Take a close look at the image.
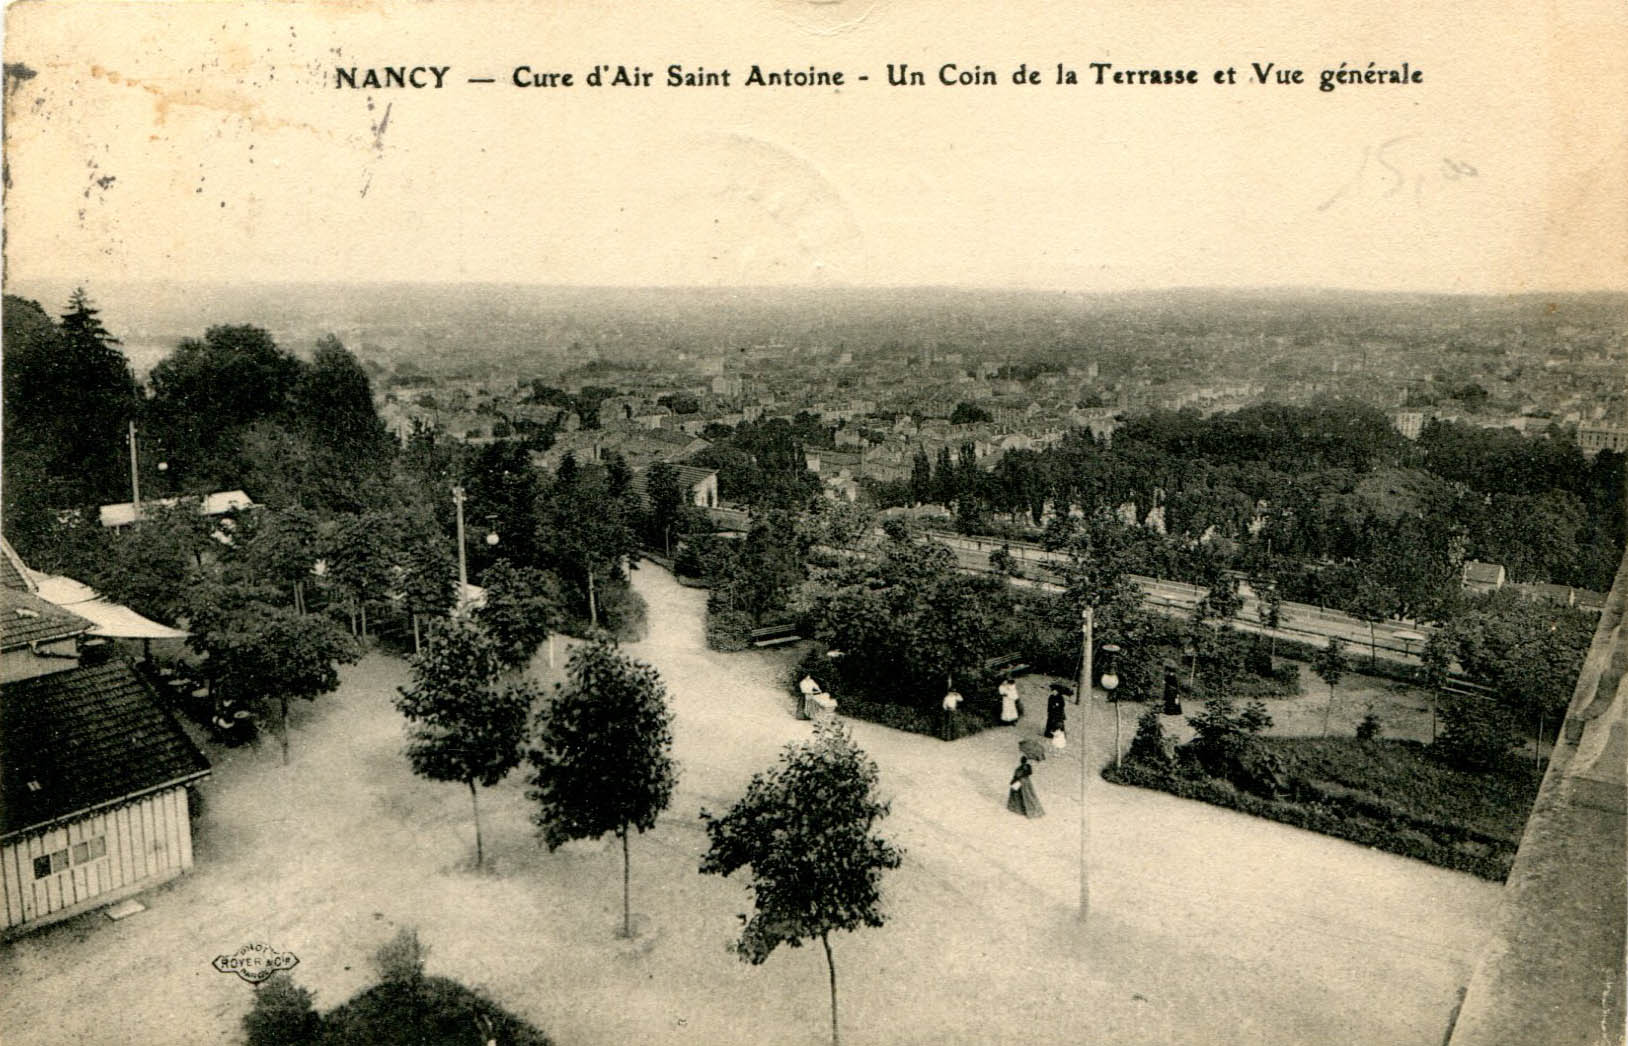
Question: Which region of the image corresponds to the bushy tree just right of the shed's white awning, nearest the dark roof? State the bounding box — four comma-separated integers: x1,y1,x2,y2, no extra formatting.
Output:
186,576,360,763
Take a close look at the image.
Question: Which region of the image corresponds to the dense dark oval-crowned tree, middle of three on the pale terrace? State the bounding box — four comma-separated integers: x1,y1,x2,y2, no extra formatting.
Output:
526,639,677,937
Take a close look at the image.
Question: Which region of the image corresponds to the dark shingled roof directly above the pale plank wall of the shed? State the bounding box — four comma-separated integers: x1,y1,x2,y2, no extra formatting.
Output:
0,660,208,838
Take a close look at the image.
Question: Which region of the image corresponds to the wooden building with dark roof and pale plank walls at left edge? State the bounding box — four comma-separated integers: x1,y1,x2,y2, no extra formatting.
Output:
0,584,208,935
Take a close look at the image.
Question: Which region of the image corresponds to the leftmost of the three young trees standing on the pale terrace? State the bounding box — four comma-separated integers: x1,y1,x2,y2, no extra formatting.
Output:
396,618,537,869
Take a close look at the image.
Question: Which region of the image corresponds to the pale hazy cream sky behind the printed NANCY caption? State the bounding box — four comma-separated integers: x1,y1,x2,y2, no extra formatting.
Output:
5,0,1628,291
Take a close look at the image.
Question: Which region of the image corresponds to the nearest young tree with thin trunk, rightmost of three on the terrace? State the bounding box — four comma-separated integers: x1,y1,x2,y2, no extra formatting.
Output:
702,722,902,1046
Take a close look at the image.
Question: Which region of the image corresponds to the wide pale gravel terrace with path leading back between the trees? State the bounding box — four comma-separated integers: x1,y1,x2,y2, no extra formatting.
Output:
0,563,1499,1046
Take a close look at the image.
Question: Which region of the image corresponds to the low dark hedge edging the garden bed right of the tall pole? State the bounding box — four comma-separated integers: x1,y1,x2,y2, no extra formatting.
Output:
1102,763,1514,883
